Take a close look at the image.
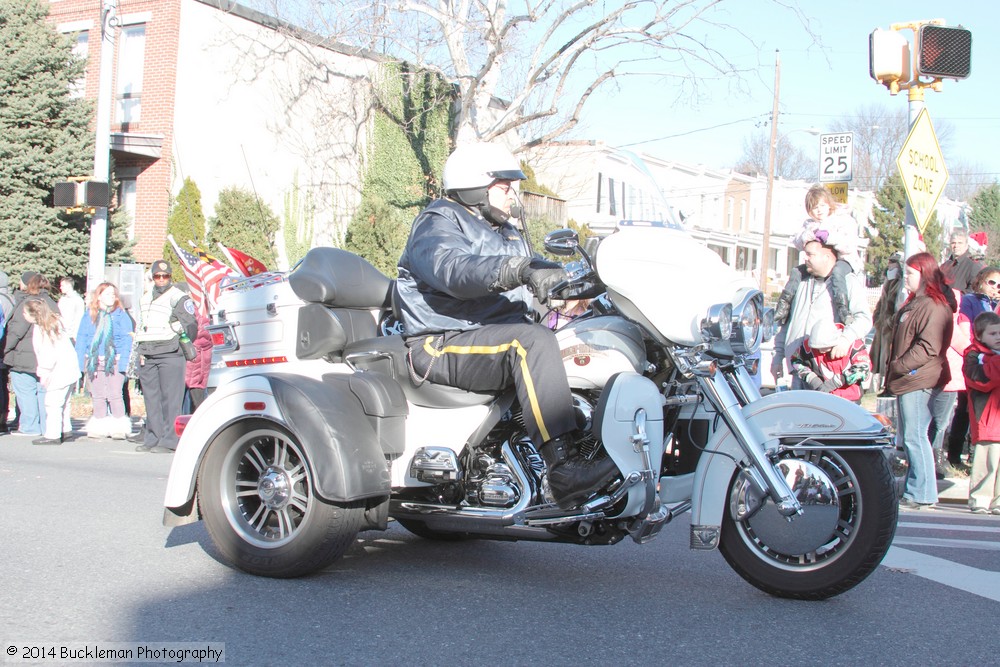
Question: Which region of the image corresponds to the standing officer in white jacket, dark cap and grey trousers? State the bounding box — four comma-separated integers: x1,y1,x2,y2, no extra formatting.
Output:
135,259,198,453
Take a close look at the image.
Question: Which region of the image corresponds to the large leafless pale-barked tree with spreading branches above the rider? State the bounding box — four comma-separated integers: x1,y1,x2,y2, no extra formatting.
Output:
248,0,808,148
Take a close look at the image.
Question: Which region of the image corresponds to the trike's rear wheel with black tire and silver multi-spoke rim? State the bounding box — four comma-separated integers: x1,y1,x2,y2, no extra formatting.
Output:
198,420,364,578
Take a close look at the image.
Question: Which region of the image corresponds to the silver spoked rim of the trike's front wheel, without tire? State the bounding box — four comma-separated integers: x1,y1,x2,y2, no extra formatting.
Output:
736,450,864,572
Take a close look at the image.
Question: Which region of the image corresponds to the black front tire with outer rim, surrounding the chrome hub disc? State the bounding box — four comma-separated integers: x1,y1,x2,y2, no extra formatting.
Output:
719,450,899,600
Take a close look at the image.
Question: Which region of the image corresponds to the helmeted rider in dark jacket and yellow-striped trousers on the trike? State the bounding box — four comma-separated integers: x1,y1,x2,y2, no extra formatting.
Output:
395,144,616,508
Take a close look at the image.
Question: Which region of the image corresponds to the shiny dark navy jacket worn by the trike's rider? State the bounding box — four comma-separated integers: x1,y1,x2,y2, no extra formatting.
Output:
395,199,533,336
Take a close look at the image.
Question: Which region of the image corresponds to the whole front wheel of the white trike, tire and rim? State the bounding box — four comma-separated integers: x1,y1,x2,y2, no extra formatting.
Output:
719,450,898,600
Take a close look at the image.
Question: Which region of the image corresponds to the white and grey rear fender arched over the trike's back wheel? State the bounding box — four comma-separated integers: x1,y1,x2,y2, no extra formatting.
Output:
164,374,394,515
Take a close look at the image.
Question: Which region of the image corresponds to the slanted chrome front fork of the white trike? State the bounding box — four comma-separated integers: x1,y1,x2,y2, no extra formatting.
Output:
698,368,802,517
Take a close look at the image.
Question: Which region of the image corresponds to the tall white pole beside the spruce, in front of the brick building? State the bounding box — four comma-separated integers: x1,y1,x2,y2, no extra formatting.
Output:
87,0,118,292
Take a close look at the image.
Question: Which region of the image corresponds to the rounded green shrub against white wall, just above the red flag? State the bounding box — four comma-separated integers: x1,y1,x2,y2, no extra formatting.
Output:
205,187,281,270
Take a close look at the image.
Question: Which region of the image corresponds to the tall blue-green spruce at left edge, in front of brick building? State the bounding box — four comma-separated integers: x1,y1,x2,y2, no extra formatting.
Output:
0,0,94,279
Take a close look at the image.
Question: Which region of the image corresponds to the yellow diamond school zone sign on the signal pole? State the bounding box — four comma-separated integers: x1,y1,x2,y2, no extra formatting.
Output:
896,109,948,234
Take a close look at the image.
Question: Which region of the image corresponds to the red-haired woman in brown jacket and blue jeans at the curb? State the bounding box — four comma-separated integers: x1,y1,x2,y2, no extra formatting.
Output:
886,252,958,509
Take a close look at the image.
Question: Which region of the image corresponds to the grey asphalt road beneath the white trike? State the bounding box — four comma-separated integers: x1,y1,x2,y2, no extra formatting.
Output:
0,436,1000,667
